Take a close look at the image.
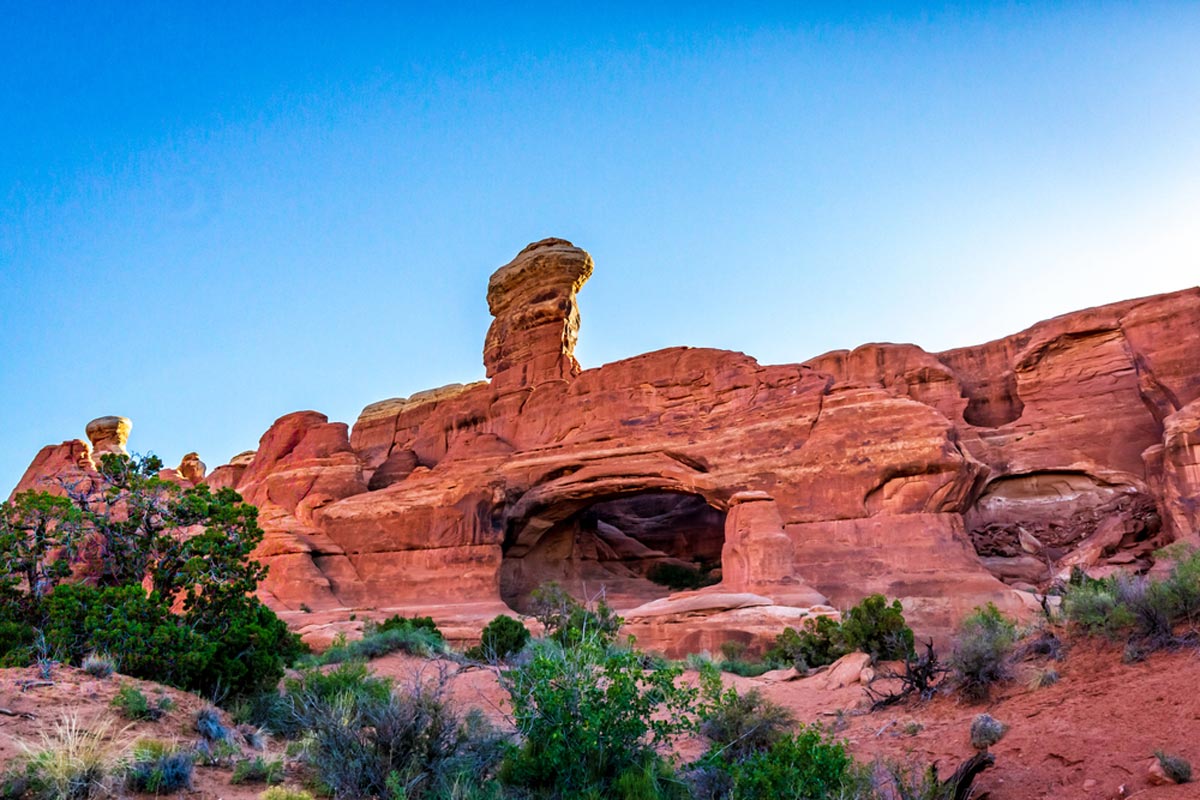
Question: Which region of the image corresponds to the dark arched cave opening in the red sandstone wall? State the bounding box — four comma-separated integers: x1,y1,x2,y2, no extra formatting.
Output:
500,491,725,613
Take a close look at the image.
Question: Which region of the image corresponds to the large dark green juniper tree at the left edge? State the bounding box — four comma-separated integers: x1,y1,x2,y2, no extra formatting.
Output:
0,453,301,696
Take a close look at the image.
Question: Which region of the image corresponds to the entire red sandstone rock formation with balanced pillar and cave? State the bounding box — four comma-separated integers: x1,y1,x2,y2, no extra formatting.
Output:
11,239,1200,652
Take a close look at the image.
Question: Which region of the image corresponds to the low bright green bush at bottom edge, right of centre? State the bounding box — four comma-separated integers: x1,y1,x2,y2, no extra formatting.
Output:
728,726,857,800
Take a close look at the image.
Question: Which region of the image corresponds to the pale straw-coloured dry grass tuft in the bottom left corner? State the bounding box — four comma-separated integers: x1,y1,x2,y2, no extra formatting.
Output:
18,714,128,800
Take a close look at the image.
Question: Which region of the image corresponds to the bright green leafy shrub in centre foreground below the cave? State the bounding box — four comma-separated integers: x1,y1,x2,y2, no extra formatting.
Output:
500,628,696,796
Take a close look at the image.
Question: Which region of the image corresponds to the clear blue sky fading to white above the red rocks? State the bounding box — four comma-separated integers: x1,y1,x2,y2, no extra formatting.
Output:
0,0,1200,495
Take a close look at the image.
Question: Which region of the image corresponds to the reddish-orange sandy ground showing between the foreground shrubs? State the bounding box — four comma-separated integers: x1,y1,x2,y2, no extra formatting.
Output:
0,642,1200,800
